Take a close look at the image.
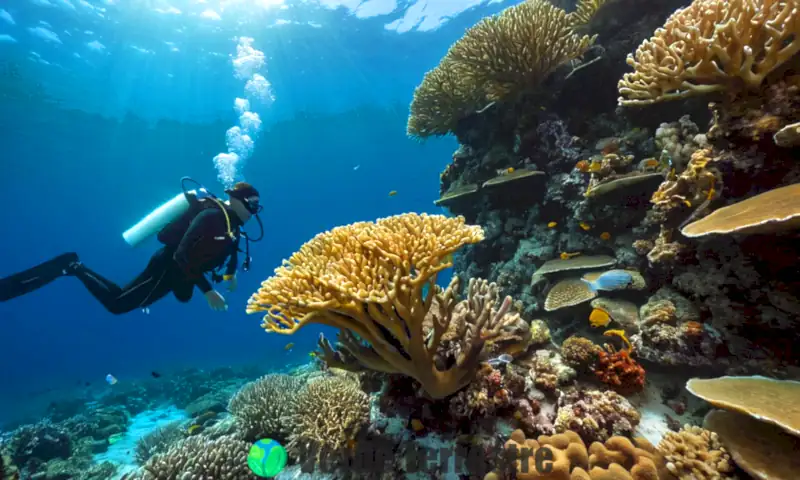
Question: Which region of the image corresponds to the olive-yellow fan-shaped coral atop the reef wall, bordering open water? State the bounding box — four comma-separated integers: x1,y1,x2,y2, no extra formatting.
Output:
407,0,595,137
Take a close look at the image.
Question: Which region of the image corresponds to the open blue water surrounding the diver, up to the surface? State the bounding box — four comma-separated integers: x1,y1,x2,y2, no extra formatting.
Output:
0,0,514,423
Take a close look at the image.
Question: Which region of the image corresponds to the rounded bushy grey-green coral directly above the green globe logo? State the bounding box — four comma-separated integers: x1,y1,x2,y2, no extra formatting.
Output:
228,374,302,440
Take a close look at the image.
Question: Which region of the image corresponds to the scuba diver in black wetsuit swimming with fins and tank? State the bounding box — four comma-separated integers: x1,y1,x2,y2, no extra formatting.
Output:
0,177,264,315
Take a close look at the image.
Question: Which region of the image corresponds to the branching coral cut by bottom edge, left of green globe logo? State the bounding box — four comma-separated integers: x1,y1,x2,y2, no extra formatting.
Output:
127,436,258,480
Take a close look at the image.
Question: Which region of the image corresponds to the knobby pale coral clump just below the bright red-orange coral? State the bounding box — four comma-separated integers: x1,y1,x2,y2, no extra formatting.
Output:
555,390,641,442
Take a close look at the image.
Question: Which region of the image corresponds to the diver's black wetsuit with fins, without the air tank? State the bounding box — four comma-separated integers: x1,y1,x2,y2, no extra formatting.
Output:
0,204,242,314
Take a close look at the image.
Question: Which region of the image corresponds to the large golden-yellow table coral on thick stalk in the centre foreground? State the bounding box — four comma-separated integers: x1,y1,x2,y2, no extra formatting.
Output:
247,213,511,398
